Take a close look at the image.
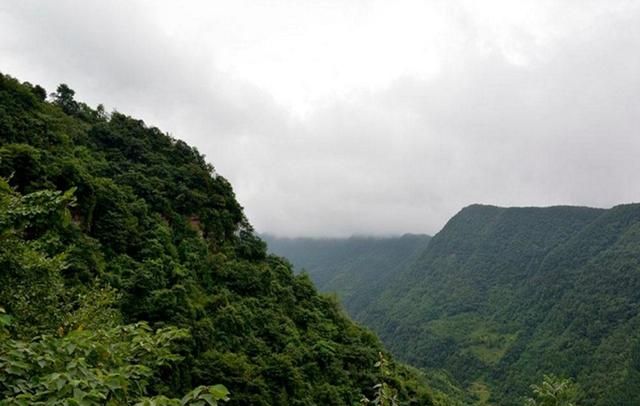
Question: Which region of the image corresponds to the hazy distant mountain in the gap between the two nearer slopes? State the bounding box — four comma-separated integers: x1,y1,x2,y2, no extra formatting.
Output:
262,234,431,320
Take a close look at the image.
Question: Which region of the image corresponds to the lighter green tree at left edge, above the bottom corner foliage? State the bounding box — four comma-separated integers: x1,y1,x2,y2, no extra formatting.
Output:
0,179,73,336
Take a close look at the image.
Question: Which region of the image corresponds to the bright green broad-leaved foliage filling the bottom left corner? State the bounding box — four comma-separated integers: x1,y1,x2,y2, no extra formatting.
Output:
0,323,188,405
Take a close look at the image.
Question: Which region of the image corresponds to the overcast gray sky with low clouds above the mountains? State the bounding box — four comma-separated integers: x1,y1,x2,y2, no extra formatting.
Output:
0,0,640,236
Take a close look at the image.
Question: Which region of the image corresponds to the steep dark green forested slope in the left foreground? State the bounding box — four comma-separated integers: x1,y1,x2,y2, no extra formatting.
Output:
0,75,450,405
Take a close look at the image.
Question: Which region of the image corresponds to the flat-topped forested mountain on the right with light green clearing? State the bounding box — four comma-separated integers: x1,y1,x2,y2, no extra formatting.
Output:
290,205,640,406
